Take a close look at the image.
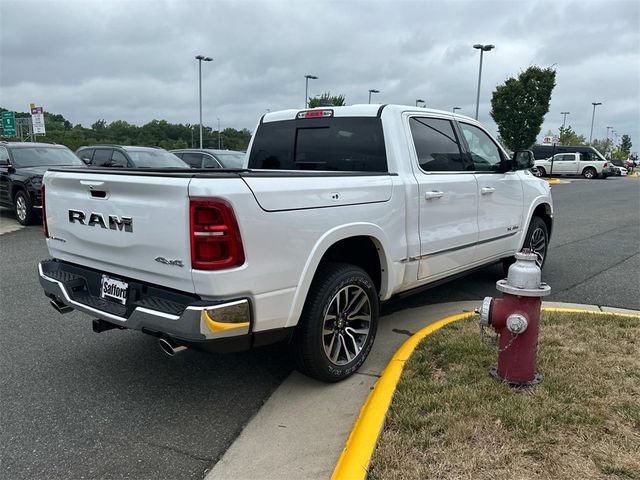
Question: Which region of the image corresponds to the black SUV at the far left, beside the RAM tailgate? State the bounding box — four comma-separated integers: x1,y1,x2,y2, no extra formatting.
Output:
0,142,86,225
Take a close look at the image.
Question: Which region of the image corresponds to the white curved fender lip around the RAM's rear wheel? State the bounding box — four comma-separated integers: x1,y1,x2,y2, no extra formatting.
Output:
286,223,395,327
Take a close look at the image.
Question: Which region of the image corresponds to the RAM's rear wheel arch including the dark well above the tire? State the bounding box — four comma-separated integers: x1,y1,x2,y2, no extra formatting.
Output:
286,223,392,327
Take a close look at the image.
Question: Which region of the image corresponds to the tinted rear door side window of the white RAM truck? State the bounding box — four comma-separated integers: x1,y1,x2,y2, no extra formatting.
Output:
409,117,465,172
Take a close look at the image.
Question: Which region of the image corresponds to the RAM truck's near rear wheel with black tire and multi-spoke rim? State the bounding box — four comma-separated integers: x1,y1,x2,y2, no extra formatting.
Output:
293,263,379,382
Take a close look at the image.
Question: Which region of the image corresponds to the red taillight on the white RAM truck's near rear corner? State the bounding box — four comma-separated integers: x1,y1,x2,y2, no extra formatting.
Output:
189,199,244,270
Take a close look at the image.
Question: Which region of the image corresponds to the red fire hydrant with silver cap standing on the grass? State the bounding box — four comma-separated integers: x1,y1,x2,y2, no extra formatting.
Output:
476,250,551,387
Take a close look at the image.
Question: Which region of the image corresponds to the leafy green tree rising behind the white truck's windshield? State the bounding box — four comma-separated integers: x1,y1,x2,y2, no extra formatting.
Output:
490,66,556,150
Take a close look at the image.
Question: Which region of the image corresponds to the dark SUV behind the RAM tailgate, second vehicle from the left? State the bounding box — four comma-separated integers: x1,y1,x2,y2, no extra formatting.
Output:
76,145,189,168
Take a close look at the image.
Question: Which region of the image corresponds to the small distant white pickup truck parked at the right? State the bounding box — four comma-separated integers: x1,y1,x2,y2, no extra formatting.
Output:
534,152,613,179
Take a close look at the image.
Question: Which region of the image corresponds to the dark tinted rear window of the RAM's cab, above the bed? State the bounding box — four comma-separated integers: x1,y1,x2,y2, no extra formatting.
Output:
249,117,387,172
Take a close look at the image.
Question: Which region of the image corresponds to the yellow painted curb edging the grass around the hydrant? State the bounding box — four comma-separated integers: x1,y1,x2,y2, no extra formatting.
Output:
331,308,640,480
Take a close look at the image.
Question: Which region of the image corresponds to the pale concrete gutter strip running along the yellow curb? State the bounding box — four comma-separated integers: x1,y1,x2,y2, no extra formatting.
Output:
206,299,639,480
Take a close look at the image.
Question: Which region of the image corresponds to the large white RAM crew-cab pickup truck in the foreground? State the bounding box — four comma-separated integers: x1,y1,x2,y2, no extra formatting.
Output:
39,105,553,381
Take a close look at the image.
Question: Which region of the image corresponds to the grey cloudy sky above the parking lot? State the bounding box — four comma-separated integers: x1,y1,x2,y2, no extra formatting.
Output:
0,0,640,146
